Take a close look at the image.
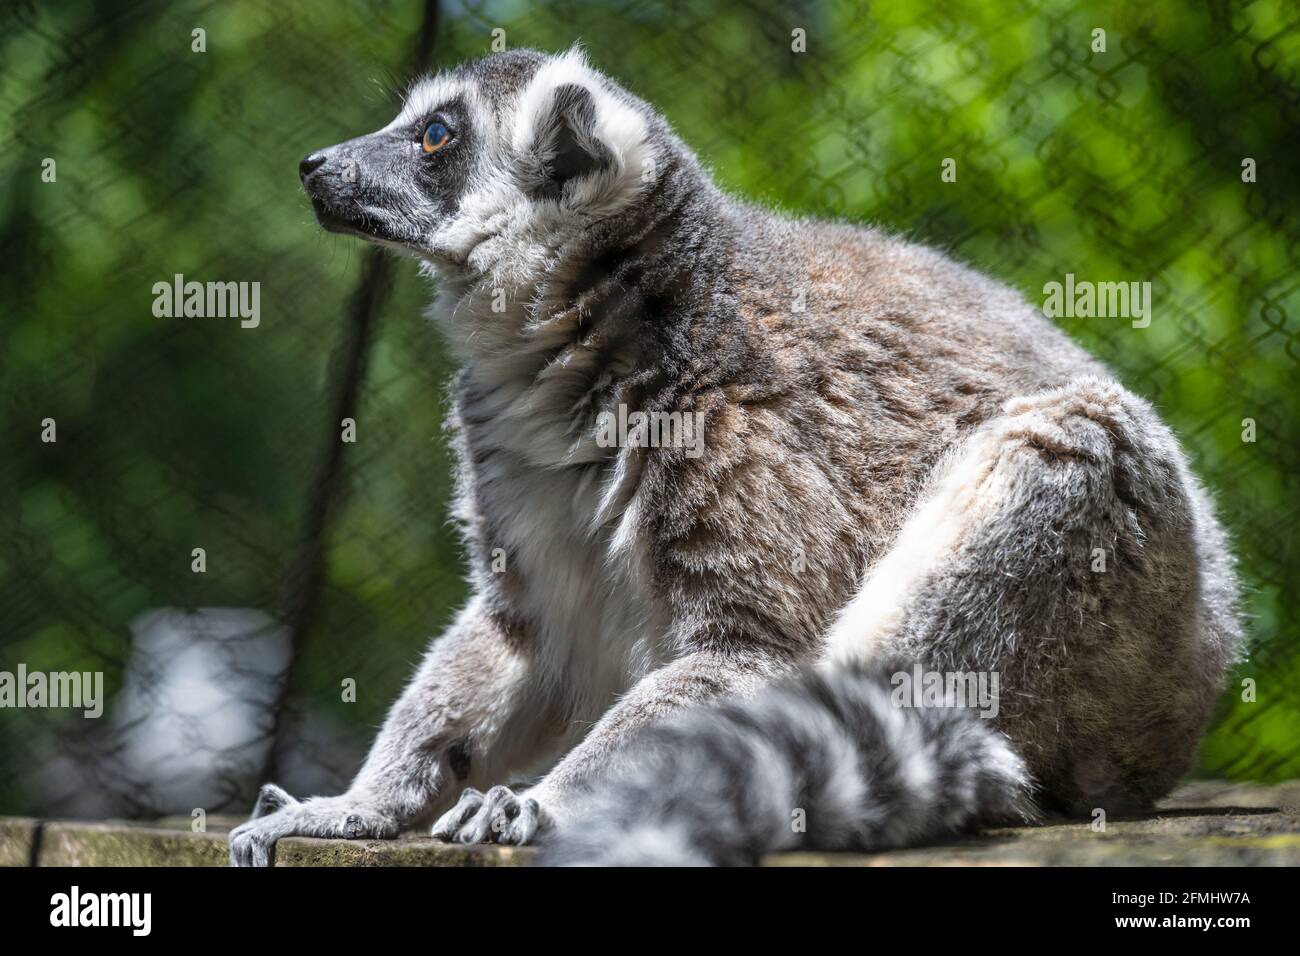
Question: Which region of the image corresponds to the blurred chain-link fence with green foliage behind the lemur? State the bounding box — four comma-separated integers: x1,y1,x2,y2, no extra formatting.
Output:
0,0,1300,816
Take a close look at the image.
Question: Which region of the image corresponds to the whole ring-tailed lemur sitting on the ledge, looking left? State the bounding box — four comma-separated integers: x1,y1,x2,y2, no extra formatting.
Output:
230,51,1240,865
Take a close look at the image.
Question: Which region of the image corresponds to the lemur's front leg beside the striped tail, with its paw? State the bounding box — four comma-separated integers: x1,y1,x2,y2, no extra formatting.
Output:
433,650,793,845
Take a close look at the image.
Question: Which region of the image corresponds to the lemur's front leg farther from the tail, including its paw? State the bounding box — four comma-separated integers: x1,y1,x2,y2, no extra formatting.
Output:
230,600,556,866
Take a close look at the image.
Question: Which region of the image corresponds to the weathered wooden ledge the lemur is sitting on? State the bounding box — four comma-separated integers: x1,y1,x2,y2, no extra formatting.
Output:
0,780,1300,866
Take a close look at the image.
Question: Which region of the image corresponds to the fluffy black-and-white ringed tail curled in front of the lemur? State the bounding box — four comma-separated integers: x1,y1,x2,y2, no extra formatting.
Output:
542,667,1034,866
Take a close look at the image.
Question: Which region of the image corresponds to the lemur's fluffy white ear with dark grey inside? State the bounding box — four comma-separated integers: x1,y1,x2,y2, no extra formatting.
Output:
514,49,650,212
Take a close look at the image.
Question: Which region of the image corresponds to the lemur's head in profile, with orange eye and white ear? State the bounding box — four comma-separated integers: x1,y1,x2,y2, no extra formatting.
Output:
299,51,658,273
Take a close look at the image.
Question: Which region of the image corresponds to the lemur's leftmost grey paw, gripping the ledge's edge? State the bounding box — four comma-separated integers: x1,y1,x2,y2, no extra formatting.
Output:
230,783,398,866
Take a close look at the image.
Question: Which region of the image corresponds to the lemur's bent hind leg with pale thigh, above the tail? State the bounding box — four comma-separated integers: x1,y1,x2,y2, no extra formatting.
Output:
828,378,1223,813
